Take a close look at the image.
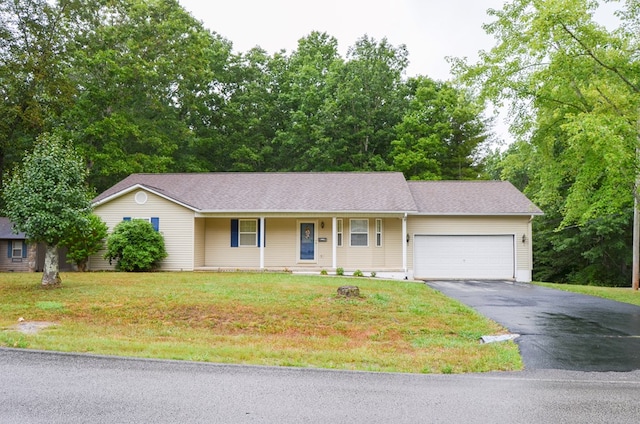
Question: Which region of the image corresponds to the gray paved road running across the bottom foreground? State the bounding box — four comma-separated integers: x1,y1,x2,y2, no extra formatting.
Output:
0,348,640,424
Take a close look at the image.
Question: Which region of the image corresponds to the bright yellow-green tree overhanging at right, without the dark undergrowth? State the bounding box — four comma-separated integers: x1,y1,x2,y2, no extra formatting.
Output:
455,0,640,287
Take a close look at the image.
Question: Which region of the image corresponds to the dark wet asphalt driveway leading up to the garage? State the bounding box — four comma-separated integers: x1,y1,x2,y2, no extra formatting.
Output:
427,281,640,371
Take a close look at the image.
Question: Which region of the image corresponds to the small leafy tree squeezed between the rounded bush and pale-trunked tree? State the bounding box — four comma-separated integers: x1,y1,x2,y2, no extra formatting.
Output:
60,213,108,271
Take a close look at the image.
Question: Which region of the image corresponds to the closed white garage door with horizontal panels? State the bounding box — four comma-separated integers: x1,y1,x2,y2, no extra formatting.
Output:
414,235,515,279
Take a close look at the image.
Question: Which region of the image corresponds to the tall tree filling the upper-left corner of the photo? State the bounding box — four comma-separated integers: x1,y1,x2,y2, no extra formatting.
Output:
0,0,90,199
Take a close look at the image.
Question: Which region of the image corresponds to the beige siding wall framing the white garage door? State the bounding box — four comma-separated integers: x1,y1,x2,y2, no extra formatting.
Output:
407,216,532,272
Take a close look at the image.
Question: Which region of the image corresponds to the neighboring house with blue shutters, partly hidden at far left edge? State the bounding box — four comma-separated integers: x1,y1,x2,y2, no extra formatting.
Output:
0,217,74,272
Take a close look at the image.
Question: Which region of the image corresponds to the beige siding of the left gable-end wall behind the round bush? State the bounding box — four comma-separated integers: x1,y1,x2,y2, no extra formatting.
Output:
89,190,194,271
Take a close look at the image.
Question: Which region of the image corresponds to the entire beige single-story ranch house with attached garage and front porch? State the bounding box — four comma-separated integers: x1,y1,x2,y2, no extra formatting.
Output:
89,172,542,281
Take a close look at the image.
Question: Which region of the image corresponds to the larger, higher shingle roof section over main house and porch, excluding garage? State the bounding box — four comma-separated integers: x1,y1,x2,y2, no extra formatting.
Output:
94,172,416,212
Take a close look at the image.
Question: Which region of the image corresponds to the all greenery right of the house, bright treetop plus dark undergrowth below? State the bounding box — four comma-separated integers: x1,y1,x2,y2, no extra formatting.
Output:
455,0,640,285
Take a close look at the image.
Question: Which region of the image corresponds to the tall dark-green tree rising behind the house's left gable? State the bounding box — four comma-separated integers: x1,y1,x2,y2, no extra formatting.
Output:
63,0,231,190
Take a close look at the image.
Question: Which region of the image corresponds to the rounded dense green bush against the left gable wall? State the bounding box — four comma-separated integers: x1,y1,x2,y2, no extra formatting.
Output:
104,219,167,272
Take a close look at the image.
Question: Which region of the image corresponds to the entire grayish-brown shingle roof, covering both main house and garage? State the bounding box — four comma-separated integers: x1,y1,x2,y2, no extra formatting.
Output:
93,172,542,215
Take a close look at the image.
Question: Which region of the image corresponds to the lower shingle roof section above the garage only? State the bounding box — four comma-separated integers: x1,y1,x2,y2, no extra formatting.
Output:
408,181,542,215
